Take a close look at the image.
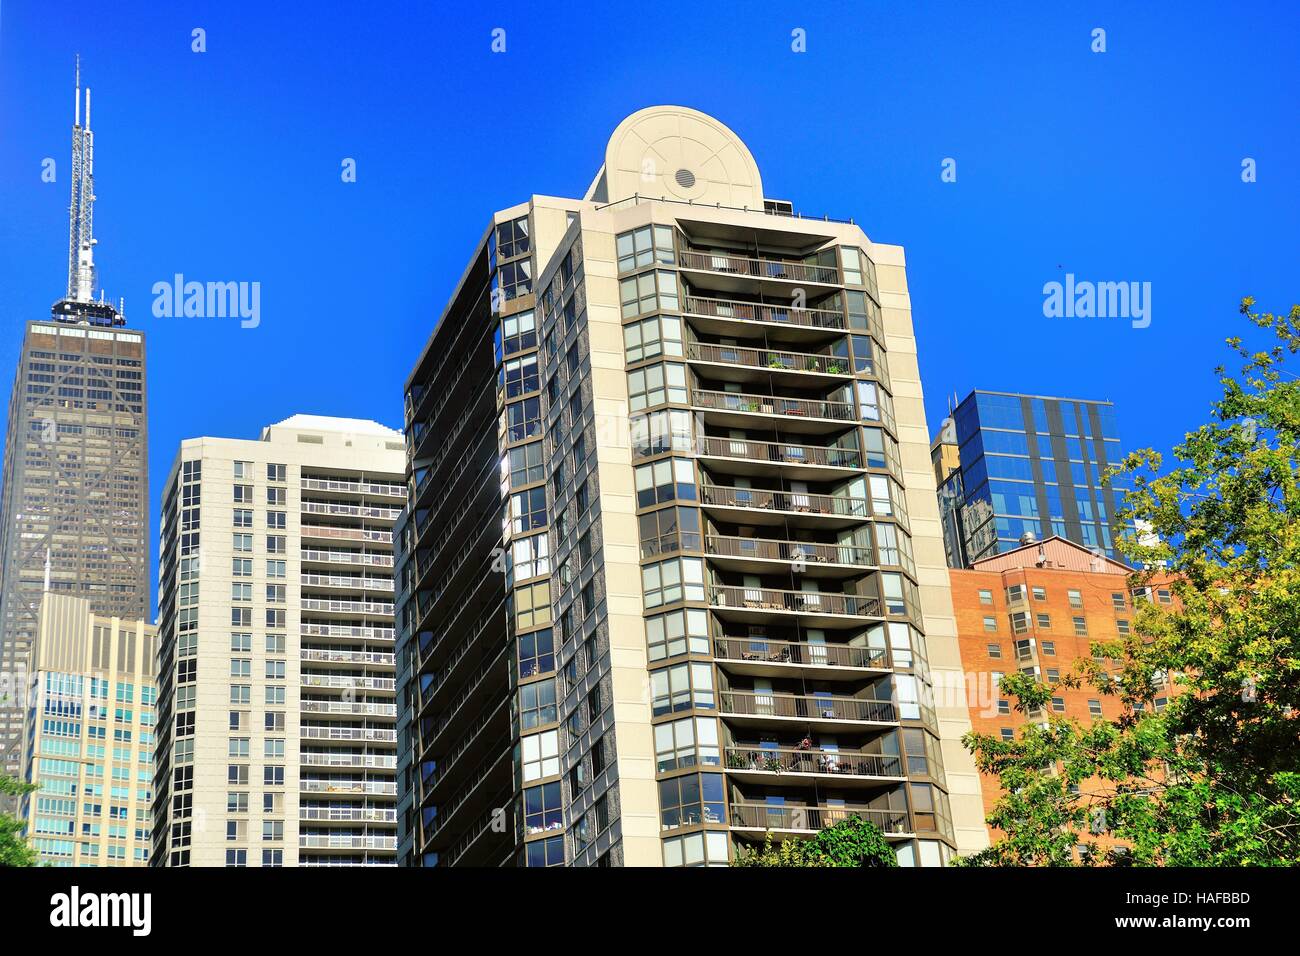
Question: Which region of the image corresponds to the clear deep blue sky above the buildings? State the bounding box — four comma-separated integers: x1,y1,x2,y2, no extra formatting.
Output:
0,0,1300,613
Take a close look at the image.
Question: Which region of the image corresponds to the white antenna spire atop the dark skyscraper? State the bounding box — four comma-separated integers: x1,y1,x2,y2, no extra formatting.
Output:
51,53,125,325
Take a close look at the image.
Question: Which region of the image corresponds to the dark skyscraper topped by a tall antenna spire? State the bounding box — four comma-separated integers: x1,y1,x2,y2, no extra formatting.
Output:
0,57,150,775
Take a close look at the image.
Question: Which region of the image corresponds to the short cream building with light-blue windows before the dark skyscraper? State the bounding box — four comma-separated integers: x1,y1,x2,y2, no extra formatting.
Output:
22,593,157,866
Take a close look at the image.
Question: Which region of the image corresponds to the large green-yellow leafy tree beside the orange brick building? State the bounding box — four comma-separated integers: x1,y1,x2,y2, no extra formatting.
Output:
962,299,1300,866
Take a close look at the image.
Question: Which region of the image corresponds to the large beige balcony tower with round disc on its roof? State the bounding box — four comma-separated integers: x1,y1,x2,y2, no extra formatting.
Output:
398,107,987,866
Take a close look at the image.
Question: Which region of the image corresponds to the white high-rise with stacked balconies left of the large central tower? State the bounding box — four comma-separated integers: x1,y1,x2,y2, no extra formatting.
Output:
153,415,406,866
